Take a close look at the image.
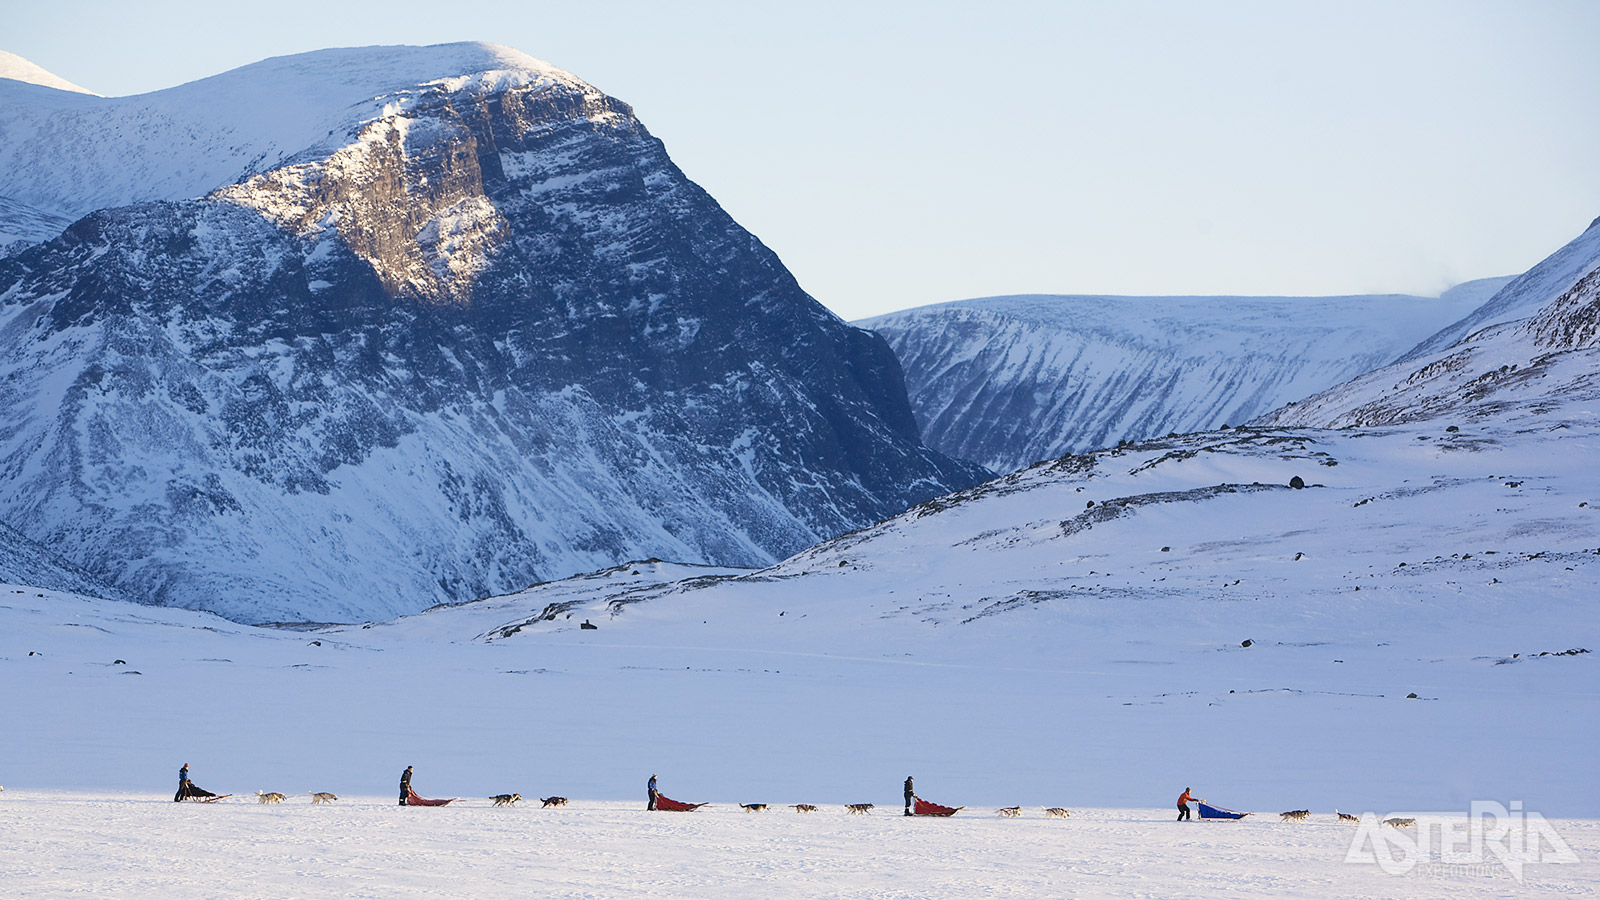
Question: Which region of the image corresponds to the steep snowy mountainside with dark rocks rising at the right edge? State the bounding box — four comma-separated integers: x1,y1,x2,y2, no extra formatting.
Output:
1262,219,1600,428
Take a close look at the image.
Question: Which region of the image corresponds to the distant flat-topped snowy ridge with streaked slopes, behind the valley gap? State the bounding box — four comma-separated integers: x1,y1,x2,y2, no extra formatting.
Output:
856,279,1509,471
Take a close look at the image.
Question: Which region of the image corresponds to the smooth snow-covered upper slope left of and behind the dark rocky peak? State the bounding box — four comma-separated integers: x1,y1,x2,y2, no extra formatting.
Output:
0,43,576,229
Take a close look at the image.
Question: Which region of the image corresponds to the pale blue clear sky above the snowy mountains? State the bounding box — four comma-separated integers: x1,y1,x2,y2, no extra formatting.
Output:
12,0,1600,319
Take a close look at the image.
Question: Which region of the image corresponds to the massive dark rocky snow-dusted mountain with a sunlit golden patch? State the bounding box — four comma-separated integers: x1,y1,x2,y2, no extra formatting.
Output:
0,45,986,621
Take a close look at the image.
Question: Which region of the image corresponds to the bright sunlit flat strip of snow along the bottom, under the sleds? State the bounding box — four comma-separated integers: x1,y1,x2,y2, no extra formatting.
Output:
0,793,1600,900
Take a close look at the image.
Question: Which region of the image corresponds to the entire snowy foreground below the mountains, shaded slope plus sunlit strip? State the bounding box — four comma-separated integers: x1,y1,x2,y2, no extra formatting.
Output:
0,404,1600,897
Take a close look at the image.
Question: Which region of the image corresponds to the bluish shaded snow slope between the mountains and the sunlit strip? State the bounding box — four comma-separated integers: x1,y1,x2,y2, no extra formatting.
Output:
0,392,1600,813
